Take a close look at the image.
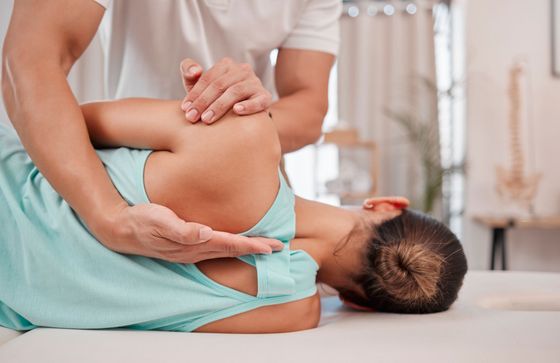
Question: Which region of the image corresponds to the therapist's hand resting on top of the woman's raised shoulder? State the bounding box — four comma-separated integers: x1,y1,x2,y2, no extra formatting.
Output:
181,58,272,124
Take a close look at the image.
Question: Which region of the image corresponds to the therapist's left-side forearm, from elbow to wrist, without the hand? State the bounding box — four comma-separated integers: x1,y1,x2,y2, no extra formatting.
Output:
2,56,125,237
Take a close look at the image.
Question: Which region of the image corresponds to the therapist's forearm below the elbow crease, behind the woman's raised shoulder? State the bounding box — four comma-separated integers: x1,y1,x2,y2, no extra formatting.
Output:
270,90,328,154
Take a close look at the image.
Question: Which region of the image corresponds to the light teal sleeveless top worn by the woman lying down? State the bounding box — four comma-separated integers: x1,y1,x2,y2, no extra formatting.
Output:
0,124,318,331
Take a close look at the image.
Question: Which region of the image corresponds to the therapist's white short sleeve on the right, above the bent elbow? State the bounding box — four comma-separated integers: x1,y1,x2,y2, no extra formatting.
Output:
280,0,342,55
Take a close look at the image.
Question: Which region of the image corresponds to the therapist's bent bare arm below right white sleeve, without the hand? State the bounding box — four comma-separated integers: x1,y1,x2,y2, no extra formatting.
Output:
271,49,334,153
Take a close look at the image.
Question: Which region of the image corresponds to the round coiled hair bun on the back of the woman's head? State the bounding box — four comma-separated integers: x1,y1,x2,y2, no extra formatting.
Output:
377,241,443,301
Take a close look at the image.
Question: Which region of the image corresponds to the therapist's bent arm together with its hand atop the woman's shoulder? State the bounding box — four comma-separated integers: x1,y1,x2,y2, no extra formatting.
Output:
181,48,334,153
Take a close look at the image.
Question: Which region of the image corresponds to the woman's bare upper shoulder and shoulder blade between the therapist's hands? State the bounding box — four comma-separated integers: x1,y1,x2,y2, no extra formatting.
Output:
144,113,280,233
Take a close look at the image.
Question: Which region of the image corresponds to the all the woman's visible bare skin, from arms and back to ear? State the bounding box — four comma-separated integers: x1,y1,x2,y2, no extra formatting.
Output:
82,99,406,333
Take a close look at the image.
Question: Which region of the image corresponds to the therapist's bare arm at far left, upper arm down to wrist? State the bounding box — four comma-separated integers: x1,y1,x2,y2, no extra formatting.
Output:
2,0,126,241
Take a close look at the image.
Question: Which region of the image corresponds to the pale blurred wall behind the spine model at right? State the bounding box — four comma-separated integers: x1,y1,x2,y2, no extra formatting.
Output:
459,0,560,271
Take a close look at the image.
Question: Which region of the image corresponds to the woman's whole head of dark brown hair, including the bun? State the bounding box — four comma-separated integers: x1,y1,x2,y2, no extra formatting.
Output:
350,210,467,314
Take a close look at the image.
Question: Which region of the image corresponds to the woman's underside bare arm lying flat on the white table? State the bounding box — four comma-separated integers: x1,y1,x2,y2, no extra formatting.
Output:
196,293,321,334
